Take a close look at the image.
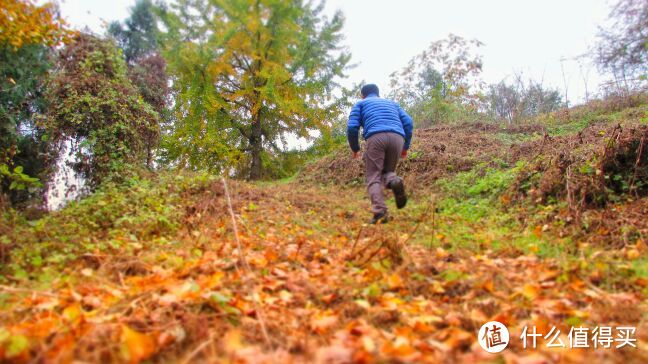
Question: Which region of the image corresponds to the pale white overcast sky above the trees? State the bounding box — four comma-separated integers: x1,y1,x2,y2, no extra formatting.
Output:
54,0,610,103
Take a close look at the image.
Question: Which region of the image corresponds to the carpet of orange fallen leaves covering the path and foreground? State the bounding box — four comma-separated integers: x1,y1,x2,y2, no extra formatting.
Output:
0,176,648,362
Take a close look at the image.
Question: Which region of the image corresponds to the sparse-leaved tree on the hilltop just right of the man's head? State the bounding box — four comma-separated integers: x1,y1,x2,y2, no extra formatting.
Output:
390,34,482,126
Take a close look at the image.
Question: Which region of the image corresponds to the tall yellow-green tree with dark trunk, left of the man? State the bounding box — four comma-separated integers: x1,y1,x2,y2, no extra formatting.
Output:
158,0,350,179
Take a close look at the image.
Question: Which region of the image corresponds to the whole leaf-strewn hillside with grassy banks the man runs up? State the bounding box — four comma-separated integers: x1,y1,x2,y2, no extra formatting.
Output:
0,98,648,363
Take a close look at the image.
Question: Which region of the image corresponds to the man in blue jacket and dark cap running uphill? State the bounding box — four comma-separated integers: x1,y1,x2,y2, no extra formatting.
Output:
347,84,414,224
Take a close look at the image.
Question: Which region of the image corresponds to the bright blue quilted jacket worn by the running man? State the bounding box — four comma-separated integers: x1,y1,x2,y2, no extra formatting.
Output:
347,94,414,152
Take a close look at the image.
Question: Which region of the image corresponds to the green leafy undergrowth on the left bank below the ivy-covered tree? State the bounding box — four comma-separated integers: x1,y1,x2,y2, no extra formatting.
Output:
0,173,214,282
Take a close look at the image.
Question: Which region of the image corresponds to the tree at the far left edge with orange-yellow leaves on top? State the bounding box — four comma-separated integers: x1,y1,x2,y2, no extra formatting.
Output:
0,0,72,203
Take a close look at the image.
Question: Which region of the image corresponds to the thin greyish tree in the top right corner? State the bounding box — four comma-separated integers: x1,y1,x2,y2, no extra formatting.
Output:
594,0,648,93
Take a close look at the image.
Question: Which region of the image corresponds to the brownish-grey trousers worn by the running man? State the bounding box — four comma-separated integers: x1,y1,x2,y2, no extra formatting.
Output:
364,132,405,214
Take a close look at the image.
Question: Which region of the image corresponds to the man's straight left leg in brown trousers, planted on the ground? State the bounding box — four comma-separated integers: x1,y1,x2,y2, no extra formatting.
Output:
364,133,387,215
